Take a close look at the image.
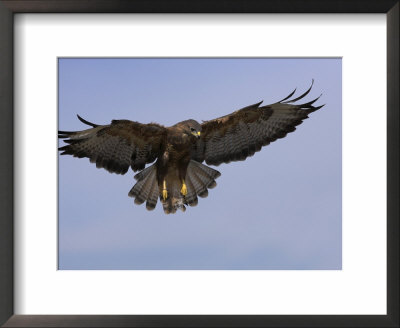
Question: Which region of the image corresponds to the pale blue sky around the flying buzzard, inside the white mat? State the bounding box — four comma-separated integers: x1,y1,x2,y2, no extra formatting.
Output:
58,58,342,270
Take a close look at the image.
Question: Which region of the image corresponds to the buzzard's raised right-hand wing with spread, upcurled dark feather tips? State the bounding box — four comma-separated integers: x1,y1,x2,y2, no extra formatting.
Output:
192,81,323,165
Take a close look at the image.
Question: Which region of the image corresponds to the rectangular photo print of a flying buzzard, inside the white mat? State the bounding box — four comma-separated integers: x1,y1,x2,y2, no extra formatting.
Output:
58,58,342,270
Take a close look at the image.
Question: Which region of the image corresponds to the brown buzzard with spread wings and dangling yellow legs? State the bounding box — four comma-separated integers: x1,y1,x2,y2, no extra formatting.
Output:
58,81,324,214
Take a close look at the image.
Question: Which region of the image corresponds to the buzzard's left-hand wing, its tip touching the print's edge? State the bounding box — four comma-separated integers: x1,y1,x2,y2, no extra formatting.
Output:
58,115,166,174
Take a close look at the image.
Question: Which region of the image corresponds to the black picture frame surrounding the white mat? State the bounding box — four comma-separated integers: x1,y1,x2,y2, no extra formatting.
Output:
0,0,400,327
